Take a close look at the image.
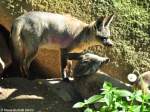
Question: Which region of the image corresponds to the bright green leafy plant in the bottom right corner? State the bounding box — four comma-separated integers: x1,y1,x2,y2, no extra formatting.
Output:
73,82,150,112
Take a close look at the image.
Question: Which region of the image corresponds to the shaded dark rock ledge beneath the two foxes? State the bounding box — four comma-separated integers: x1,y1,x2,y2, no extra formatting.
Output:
0,72,131,112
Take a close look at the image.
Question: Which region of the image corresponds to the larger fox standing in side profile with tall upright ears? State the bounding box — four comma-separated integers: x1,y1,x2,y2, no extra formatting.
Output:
10,11,113,77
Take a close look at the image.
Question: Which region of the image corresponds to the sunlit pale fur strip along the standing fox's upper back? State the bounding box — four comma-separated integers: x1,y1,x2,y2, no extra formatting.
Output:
19,11,87,34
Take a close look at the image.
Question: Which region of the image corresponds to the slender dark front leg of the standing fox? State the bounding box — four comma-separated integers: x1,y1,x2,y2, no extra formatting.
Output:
61,49,69,82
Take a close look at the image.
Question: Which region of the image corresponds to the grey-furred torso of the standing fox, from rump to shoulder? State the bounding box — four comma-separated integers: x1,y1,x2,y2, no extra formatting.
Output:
16,12,87,48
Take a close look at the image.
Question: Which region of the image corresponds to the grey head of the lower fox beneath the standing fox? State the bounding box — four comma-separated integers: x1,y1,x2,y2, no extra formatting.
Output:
73,53,109,77
